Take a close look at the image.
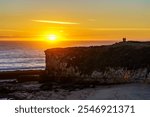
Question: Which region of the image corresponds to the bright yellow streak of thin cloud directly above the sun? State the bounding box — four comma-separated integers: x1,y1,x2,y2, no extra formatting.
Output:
32,20,80,25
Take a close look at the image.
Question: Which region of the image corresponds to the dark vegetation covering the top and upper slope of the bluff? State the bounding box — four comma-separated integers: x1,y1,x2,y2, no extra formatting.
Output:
46,42,150,73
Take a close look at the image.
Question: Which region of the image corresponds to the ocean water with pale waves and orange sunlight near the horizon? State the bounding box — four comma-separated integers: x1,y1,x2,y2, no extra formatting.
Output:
0,41,114,71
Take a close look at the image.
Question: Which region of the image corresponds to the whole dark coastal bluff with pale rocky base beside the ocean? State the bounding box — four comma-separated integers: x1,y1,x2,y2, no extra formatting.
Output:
45,41,150,84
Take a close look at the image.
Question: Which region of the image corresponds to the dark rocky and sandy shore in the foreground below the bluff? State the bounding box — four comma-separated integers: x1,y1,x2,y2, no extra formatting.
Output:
0,70,150,100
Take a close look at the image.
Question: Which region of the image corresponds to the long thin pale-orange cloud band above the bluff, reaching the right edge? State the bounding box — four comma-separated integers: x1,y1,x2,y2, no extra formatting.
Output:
90,28,150,31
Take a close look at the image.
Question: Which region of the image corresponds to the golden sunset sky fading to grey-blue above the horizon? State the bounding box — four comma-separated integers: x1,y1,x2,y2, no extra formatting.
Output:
0,0,150,41
